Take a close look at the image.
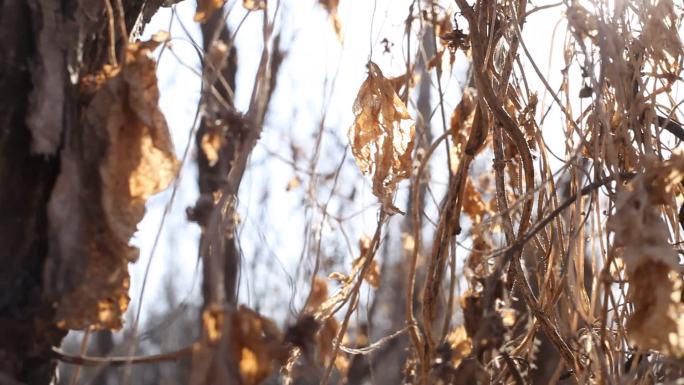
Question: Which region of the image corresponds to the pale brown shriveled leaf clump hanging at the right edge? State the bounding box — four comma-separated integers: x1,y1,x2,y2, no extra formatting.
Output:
609,152,684,357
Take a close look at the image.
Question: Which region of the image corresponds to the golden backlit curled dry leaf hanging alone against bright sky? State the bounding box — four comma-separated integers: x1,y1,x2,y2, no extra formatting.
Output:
349,62,415,213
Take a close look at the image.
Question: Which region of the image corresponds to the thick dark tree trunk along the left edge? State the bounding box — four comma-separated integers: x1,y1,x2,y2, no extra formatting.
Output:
0,0,165,384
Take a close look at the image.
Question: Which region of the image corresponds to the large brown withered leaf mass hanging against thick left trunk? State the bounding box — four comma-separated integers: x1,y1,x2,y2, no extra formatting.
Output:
46,35,179,329
